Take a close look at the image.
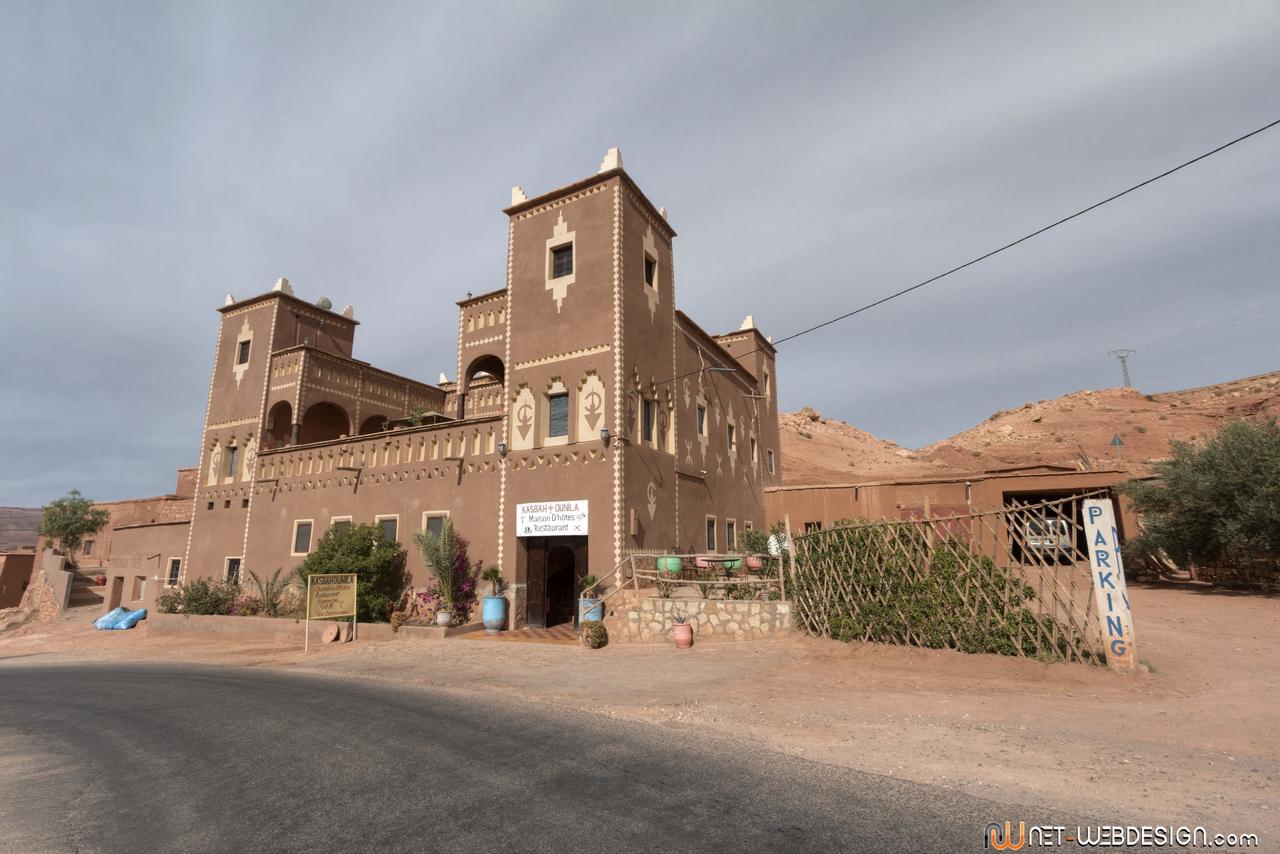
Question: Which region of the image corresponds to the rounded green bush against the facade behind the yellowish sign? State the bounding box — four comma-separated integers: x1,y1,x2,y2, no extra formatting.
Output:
294,525,408,622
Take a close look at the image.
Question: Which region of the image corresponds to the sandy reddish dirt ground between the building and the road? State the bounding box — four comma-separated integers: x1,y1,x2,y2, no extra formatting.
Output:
0,586,1280,849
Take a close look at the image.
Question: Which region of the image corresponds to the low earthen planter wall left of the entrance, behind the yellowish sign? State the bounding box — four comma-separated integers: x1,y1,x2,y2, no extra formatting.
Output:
138,612,484,645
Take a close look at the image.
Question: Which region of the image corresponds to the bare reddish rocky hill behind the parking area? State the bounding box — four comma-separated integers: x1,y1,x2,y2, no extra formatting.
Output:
781,371,1280,484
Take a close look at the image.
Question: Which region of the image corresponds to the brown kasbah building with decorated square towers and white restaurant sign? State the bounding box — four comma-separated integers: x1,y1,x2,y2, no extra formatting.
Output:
92,149,782,627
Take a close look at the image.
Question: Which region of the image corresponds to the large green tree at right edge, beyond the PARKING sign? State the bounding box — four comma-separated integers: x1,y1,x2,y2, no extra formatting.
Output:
1120,419,1280,568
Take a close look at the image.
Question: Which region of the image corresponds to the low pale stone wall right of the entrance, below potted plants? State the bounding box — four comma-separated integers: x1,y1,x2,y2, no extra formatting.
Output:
605,598,791,643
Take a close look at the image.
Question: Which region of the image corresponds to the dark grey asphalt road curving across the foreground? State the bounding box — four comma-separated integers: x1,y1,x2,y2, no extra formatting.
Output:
0,662,1074,853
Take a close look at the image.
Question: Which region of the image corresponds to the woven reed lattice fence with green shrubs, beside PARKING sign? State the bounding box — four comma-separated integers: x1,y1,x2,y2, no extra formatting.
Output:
787,490,1107,665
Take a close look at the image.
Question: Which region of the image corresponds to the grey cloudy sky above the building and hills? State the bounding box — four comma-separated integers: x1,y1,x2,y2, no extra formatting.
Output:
0,0,1280,506
